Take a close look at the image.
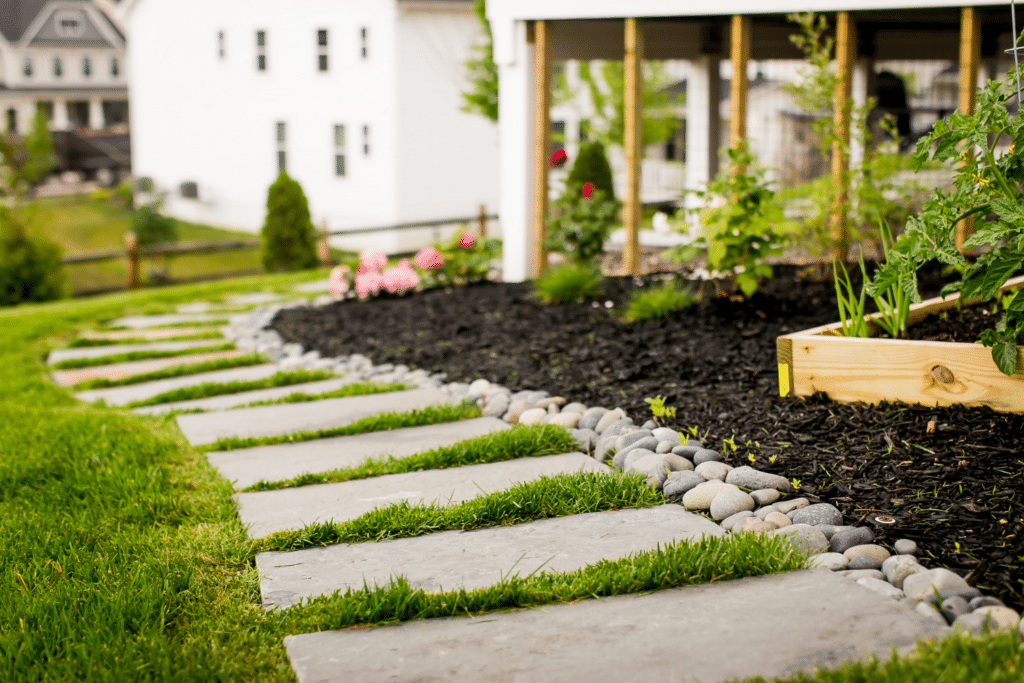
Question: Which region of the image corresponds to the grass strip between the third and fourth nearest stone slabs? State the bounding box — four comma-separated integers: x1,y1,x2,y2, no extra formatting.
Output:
243,425,577,492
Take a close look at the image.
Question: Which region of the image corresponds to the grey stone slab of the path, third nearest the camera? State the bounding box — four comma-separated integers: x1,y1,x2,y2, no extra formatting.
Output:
234,453,611,539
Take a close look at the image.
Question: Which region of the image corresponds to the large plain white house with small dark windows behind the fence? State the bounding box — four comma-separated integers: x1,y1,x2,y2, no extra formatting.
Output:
122,0,498,252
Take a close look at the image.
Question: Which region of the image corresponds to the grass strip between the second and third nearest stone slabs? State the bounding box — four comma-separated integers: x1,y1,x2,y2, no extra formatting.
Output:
256,472,665,551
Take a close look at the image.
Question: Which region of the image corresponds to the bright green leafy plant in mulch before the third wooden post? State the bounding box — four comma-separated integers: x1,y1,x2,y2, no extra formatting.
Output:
670,144,784,297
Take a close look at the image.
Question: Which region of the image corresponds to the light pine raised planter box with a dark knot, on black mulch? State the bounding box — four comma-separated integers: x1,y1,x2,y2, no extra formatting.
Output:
776,276,1024,413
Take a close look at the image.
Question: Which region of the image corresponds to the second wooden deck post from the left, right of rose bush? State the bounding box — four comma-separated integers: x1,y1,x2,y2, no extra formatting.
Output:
623,17,643,275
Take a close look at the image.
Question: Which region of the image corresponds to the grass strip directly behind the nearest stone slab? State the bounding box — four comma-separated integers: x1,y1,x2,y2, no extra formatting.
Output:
280,533,805,634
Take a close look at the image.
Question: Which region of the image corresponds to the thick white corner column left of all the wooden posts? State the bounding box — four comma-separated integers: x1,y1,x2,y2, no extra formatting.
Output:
495,22,535,283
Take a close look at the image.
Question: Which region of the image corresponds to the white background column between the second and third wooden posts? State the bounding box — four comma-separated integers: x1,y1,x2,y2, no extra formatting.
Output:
686,56,722,224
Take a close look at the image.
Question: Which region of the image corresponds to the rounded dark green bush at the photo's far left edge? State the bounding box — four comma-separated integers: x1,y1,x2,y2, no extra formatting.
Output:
0,207,68,306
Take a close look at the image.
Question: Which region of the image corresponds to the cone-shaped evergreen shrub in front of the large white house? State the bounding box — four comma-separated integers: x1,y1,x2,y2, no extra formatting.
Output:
262,171,317,272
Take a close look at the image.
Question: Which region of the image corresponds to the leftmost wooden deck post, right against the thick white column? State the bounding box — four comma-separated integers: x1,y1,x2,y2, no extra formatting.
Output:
531,22,551,276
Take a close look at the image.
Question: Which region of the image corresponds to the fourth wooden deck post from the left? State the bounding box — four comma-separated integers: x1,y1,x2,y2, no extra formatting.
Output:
829,12,857,263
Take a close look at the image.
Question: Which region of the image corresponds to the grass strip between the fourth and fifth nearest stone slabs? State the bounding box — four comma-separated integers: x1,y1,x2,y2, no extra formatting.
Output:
202,401,480,453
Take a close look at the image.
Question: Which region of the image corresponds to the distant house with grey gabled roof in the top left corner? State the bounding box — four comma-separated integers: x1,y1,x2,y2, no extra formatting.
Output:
0,0,128,132
